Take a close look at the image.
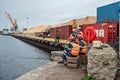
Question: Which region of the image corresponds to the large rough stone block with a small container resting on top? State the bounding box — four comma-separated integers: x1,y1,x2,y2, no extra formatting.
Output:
87,46,117,80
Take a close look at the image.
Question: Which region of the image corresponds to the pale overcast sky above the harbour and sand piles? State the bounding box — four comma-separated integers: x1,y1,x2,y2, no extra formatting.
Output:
0,0,119,30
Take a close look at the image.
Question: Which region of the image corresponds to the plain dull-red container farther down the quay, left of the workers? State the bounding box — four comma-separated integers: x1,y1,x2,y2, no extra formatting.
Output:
50,25,72,39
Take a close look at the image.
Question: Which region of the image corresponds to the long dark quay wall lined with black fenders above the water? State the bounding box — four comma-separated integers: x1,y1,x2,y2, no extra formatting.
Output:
11,35,65,52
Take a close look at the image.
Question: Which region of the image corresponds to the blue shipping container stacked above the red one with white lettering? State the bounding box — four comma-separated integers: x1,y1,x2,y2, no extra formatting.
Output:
97,2,120,23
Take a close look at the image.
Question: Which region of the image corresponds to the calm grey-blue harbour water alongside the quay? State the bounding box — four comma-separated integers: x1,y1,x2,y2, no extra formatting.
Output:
0,35,49,80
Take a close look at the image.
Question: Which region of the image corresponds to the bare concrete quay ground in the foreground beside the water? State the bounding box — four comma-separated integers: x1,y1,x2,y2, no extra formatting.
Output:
16,61,86,80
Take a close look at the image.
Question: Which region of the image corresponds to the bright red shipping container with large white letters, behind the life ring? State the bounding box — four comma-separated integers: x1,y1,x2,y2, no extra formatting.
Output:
82,22,118,43
